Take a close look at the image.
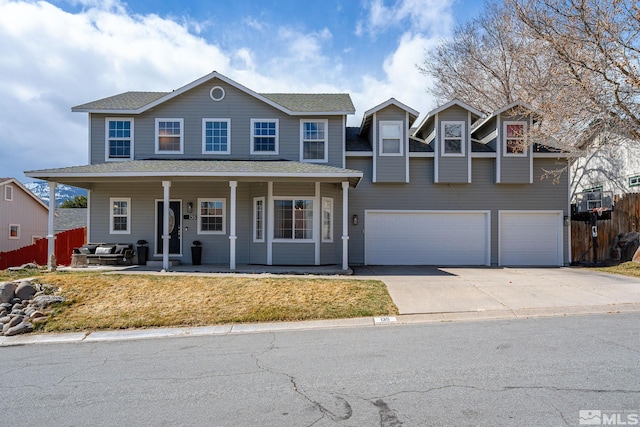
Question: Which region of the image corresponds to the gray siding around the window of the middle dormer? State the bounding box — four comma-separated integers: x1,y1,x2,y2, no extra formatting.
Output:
435,105,471,184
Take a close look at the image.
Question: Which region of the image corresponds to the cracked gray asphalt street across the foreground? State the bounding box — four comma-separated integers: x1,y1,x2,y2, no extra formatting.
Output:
0,313,640,427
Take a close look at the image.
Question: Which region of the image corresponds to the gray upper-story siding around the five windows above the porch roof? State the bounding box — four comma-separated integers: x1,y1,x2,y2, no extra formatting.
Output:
91,80,344,167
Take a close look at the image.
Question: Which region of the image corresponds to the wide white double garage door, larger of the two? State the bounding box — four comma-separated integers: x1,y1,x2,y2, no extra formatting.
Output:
365,211,491,265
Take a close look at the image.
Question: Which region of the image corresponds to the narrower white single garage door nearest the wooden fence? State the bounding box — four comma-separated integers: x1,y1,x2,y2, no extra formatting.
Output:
498,211,563,266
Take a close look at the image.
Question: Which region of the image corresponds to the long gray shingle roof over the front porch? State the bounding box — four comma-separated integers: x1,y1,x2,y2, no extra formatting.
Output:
25,160,362,187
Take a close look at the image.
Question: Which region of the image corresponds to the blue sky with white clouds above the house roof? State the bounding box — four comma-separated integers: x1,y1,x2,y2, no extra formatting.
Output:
0,0,482,181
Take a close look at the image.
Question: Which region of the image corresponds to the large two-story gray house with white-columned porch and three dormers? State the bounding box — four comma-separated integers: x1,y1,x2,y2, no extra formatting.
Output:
27,72,570,270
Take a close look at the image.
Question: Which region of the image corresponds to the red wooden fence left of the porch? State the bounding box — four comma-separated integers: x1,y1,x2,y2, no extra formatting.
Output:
0,227,87,270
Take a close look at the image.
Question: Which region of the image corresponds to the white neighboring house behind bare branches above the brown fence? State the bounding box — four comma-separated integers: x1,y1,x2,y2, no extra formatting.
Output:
571,132,640,212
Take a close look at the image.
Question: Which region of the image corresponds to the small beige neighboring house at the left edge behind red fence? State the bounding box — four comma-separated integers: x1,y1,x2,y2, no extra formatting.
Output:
0,178,49,252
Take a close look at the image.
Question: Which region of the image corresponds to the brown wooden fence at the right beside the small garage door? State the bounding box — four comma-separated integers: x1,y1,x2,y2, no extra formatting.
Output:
571,193,640,262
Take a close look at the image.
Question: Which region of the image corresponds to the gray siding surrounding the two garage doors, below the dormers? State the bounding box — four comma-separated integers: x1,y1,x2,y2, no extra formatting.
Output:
347,157,569,265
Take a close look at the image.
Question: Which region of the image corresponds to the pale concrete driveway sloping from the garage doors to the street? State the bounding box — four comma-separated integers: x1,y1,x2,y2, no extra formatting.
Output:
354,266,640,316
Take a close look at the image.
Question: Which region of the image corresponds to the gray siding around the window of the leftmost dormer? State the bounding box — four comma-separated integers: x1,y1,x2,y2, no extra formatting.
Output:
374,105,408,183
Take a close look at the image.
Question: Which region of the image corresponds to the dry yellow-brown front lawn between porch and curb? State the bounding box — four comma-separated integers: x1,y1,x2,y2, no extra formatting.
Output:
11,272,398,331
